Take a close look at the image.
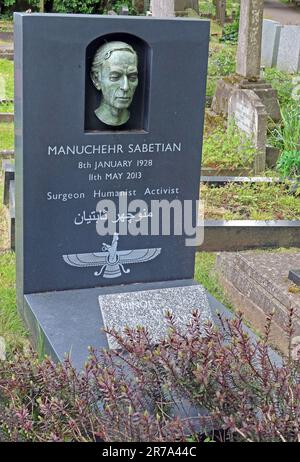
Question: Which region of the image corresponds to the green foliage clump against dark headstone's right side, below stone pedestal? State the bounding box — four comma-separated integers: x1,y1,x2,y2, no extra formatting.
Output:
203,124,256,170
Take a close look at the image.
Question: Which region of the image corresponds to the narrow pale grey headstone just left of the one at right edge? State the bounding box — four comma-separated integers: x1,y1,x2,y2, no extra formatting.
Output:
261,19,282,67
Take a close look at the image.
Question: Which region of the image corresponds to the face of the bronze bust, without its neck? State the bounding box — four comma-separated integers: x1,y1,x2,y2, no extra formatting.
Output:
97,50,138,109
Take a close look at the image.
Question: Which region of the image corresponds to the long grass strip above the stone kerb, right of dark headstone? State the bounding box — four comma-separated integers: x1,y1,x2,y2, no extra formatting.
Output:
201,183,300,220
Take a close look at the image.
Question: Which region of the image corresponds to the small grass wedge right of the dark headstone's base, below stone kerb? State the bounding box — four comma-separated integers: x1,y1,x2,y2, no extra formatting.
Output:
195,252,233,310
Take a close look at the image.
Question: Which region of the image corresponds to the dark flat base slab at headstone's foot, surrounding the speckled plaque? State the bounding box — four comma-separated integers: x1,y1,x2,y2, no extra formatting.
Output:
24,280,227,369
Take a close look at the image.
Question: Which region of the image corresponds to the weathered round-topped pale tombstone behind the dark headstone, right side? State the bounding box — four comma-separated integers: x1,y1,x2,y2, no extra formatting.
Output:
228,90,268,174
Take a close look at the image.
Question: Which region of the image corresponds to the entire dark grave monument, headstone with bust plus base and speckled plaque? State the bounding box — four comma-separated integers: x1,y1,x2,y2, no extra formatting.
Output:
15,13,209,367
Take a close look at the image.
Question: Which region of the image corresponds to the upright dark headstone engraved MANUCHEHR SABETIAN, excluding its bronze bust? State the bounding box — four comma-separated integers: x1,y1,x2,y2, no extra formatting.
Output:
14,13,209,366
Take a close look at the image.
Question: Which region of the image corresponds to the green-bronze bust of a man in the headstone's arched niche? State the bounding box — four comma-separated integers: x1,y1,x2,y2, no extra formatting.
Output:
91,41,138,127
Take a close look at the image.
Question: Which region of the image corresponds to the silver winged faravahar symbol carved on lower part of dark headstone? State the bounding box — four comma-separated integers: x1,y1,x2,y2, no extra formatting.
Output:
63,233,161,279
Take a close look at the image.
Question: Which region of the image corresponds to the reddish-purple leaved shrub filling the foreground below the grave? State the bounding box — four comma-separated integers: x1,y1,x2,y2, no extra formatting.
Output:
0,312,300,442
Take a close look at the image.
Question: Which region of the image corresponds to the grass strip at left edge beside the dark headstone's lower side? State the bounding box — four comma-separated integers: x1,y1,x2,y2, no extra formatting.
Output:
0,252,27,352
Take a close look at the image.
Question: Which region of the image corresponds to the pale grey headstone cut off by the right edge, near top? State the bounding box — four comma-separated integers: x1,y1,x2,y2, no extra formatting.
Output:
277,26,300,73
